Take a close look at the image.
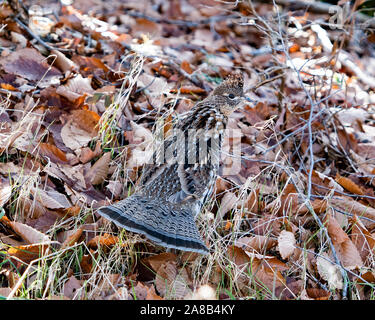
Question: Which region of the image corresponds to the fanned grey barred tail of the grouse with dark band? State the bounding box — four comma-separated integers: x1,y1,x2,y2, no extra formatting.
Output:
98,195,208,254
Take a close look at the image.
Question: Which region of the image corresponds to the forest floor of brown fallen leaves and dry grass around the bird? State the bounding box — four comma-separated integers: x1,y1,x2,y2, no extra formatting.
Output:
0,0,375,300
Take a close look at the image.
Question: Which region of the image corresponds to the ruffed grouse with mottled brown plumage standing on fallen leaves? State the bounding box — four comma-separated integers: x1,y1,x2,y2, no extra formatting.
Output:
98,75,245,253
